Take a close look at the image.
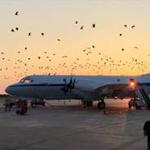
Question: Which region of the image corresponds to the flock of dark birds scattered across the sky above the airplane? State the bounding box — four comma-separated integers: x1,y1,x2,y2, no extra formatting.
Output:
0,11,147,80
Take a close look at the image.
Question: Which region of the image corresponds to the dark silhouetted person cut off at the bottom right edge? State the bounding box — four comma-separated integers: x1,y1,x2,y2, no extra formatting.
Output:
143,120,150,150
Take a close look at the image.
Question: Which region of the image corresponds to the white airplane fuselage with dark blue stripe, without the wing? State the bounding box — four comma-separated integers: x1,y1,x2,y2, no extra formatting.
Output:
6,75,150,99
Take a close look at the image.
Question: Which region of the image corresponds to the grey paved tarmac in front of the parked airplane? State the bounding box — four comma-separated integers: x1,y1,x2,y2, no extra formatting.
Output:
0,99,150,150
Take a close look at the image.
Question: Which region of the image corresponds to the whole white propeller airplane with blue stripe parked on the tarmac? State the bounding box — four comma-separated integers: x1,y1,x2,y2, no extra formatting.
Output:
5,74,150,109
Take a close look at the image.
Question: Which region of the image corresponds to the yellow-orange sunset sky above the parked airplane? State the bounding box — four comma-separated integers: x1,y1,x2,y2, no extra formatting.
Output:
0,0,150,94
